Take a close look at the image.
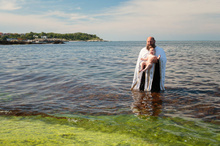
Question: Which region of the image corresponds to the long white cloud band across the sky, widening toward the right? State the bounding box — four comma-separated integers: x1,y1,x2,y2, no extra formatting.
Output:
0,0,220,40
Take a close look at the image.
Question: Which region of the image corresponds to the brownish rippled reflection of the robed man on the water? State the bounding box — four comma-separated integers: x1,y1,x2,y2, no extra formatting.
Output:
131,91,162,116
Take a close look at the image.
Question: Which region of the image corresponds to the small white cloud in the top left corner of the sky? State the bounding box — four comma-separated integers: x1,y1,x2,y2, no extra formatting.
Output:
0,0,21,10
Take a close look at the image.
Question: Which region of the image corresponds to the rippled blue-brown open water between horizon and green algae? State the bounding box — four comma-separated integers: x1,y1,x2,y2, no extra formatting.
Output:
0,41,220,123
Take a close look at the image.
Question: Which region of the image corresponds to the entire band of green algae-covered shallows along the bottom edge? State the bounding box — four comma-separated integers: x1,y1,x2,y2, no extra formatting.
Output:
0,115,220,145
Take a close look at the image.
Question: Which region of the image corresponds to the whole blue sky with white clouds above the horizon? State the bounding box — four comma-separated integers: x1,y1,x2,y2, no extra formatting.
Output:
0,0,220,41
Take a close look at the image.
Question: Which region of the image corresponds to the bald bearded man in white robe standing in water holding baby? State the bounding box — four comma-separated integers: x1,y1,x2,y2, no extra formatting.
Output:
131,37,167,91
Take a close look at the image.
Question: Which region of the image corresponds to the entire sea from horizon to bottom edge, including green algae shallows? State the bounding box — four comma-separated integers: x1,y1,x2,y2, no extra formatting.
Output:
0,41,220,145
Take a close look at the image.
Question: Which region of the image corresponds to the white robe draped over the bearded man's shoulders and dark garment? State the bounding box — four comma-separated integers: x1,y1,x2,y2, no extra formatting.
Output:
131,47,167,91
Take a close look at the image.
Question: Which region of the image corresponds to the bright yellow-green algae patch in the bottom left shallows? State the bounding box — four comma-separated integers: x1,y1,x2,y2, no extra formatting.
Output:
0,116,151,146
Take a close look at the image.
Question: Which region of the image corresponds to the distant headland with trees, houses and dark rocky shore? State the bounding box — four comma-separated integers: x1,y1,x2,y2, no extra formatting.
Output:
0,32,105,45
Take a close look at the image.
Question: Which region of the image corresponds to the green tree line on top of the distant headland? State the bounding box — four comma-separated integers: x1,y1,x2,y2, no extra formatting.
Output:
0,32,102,41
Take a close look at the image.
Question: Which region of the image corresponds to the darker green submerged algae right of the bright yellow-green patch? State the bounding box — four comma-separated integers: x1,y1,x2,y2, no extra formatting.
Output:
64,115,220,145
